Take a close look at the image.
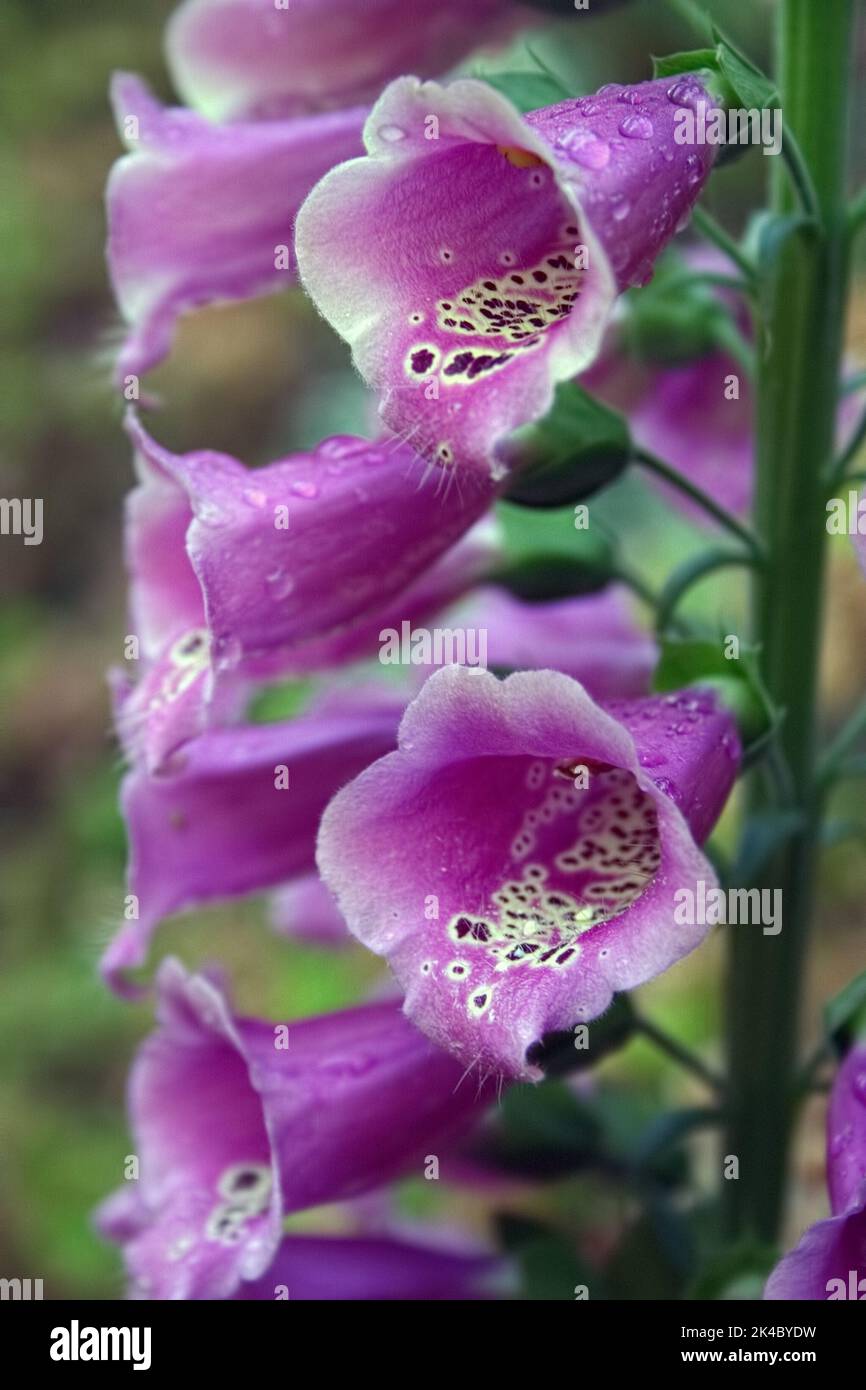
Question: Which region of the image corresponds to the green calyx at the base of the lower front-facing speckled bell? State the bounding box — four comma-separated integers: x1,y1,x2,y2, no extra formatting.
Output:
652,637,781,760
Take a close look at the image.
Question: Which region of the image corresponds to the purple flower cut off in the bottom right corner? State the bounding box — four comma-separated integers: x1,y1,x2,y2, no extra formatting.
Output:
763,1041,866,1302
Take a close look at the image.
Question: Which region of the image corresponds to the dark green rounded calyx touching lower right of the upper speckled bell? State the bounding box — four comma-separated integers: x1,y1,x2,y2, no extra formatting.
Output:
506,381,631,507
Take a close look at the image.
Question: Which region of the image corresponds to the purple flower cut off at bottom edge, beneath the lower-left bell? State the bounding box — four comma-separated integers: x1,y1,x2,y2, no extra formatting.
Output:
232,1236,505,1302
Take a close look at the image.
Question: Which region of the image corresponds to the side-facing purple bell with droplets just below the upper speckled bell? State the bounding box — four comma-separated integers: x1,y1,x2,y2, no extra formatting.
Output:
128,405,496,678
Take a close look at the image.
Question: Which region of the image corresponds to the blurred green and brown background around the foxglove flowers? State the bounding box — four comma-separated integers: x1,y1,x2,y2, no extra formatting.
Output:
0,0,866,1298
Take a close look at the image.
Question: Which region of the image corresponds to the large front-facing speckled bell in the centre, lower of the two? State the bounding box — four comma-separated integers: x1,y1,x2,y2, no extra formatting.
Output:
318,667,740,1077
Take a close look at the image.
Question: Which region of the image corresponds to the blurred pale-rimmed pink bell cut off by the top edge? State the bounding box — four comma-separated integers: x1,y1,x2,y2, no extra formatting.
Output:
167,0,525,121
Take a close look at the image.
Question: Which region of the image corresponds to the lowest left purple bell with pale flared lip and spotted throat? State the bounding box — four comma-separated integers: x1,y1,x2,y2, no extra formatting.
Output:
97,960,489,1298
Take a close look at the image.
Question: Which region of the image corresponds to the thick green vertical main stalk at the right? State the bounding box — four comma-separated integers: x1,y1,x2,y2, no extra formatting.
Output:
724,0,853,1240
